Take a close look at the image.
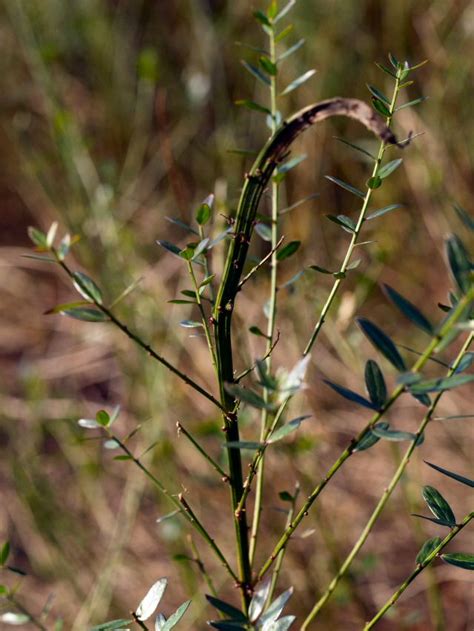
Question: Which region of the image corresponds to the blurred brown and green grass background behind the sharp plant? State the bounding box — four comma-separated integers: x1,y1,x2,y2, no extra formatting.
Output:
0,0,474,631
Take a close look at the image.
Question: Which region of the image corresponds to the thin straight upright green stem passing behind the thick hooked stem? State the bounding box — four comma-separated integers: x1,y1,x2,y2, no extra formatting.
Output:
249,13,279,566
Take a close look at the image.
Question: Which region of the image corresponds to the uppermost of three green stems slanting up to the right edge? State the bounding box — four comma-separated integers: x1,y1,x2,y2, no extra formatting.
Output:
257,288,474,580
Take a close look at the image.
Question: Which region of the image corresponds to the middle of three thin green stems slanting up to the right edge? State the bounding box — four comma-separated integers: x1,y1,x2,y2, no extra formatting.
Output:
301,334,474,631
